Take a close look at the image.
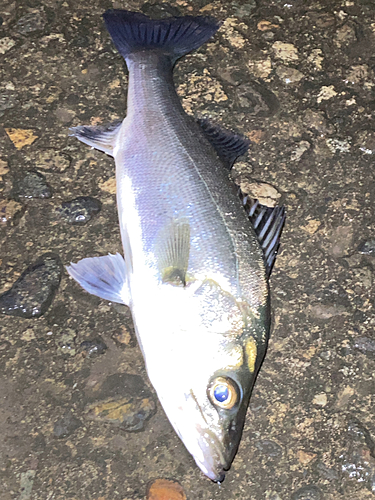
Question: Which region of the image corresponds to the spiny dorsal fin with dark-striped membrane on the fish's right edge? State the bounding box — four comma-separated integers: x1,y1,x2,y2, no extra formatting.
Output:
240,191,285,277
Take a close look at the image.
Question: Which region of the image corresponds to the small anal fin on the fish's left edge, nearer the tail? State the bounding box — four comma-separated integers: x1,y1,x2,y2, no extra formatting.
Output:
69,120,122,156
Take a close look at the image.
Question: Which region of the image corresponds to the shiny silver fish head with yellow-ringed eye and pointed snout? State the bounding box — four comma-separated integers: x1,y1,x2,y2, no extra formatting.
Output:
142,283,267,482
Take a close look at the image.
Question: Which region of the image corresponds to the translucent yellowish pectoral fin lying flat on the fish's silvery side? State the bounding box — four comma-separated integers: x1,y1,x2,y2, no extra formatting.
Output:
155,219,190,286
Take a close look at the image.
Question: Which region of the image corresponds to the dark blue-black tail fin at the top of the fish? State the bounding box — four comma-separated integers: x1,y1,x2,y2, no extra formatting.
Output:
103,9,221,62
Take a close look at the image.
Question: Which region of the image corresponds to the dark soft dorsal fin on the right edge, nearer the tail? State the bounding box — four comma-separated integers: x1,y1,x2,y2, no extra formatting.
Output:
198,119,250,169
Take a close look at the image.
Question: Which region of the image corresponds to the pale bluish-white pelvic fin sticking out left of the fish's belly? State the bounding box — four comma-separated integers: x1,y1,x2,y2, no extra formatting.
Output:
66,253,130,305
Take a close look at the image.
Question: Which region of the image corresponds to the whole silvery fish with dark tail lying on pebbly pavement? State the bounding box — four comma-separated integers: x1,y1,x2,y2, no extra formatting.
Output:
67,9,285,483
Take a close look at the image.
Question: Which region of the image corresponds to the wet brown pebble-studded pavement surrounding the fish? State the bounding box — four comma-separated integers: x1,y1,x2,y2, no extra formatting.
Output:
0,0,375,500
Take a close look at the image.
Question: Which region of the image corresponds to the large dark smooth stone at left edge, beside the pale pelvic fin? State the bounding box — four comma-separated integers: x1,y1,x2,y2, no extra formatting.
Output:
0,253,62,318
